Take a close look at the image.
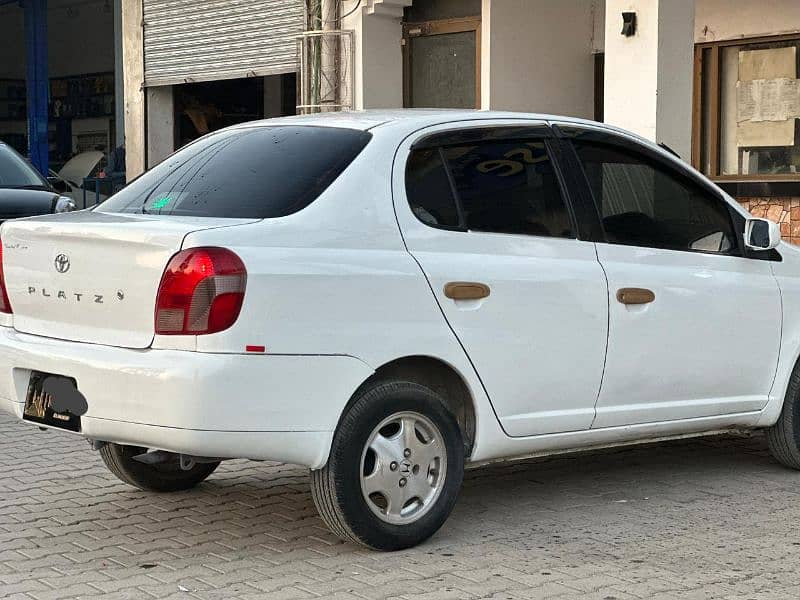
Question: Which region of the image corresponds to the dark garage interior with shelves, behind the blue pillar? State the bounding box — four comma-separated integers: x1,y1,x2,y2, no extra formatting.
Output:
0,0,122,176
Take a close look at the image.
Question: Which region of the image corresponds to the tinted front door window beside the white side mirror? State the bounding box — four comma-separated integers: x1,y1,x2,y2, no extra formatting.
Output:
573,140,737,254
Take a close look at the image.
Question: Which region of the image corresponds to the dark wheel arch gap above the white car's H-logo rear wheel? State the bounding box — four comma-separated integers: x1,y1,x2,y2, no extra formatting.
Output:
336,355,476,457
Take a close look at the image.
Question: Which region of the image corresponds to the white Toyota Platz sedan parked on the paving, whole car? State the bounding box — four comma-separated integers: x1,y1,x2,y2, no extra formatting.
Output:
0,111,800,550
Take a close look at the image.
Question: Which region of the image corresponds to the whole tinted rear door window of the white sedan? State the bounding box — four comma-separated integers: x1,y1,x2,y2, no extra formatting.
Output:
406,140,574,237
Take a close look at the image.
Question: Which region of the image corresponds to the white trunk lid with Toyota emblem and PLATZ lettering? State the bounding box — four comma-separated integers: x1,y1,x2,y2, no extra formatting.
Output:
0,211,256,348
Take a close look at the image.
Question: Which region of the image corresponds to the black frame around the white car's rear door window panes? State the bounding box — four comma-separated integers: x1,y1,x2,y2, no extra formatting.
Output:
403,123,586,240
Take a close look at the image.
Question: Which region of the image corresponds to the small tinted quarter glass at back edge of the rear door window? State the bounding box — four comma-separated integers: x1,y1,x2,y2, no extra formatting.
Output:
406,148,458,227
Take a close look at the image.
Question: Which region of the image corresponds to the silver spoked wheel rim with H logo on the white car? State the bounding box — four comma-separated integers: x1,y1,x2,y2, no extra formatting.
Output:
360,412,447,525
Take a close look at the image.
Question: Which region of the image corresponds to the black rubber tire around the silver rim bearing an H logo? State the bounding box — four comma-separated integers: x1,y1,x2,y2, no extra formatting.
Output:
311,381,464,551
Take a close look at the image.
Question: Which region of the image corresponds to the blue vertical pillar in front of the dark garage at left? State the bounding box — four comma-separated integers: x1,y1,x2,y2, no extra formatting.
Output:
25,0,50,177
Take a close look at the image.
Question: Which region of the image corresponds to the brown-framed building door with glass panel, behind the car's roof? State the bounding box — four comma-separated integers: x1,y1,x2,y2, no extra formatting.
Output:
403,17,481,108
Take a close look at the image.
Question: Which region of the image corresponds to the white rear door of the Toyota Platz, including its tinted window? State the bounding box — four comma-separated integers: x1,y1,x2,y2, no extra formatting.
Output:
394,121,608,436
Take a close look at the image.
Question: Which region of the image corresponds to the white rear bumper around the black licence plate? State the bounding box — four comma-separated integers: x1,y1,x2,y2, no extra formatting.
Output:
0,327,372,468
